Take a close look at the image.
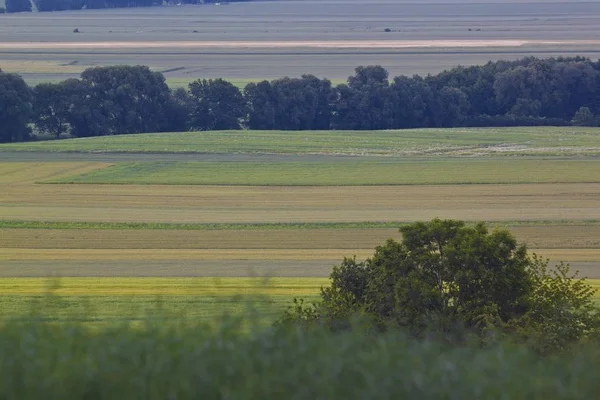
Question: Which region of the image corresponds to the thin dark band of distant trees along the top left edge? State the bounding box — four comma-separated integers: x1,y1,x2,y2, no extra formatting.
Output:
2,0,251,13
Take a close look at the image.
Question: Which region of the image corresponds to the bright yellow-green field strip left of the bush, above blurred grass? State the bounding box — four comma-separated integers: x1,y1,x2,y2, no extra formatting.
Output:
0,278,328,322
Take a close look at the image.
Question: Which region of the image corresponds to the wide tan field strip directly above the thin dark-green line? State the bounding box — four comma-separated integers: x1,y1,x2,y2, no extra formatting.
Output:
0,183,600,224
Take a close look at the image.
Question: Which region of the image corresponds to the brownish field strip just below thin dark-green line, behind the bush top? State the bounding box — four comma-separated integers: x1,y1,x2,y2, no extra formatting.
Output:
0,223,600,250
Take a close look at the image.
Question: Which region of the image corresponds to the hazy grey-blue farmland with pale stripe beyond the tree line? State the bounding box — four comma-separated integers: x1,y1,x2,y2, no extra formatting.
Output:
0,0,600,87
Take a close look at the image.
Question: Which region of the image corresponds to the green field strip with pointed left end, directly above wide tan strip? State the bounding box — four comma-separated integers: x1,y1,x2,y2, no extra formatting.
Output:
51,159,600,186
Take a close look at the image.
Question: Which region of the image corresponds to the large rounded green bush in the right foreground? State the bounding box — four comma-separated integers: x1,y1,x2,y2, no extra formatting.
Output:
302,219,600,352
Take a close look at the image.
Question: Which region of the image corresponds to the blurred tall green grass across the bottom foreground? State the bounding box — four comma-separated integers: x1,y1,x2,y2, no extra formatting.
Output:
0,318,600,400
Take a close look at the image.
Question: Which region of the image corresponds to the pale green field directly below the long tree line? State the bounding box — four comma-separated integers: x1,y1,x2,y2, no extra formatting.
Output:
0,127,600,156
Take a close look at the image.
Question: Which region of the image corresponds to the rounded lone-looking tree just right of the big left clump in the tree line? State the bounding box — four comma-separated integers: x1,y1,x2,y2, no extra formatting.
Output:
189,79,246,131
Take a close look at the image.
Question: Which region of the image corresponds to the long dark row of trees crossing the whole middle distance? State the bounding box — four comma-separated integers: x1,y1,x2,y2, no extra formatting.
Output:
0,57,600,142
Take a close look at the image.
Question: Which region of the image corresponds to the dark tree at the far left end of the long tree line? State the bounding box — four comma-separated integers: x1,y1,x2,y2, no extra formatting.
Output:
0,70,32,142
